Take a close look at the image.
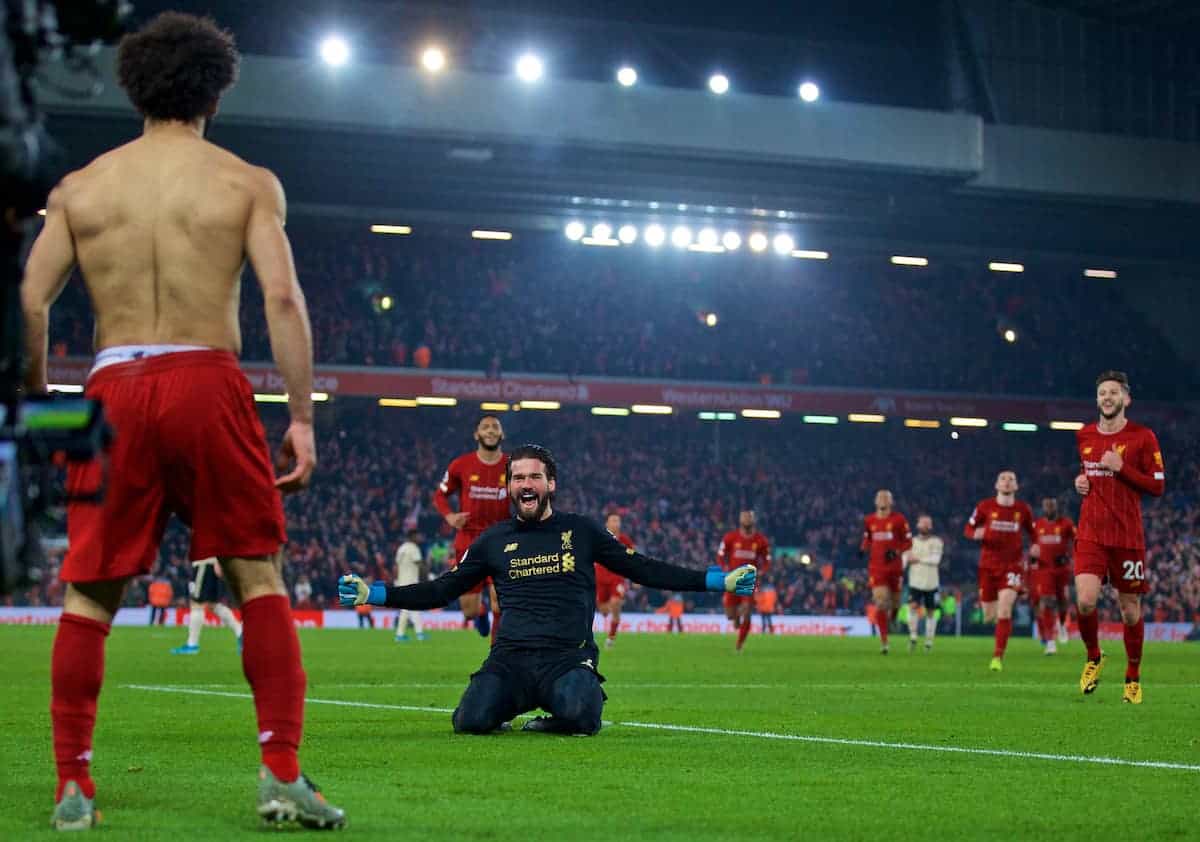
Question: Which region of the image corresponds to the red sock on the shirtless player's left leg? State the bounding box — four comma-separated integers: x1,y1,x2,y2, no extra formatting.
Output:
50,613,110,802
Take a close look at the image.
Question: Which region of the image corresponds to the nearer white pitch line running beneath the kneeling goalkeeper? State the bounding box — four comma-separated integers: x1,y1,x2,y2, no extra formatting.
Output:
121,684,1200,772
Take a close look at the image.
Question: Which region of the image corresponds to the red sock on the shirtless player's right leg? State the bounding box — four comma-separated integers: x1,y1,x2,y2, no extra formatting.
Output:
241,595,306,782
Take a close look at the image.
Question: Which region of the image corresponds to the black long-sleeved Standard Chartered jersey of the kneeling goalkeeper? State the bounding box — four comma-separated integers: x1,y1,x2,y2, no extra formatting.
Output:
386,512,704,649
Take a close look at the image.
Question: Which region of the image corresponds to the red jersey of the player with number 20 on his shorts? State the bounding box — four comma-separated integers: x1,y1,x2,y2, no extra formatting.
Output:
1075,421,1166,549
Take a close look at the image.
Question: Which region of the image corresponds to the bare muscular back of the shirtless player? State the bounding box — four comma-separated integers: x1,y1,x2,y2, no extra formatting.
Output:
62,127,263,353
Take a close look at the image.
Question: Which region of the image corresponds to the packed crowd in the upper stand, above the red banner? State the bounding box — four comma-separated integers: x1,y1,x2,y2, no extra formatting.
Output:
50,222,1189,398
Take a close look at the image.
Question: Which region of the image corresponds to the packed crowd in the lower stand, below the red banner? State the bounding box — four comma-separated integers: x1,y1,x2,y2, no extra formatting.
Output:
11,401,1200,621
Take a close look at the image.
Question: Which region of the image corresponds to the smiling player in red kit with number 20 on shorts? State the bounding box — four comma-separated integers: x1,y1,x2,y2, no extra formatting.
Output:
1075,371,1166,704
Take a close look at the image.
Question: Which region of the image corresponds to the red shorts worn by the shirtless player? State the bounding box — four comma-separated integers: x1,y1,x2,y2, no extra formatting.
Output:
61,350,287,582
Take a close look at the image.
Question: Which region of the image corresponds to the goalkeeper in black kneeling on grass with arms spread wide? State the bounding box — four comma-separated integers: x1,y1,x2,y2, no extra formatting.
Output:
337,445,756,734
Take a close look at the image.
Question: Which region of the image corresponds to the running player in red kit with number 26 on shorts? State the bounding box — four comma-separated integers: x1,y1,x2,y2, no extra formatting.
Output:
962,470,1034,673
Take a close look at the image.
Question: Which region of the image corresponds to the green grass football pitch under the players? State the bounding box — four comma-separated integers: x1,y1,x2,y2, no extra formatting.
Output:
0,627,1200,842
